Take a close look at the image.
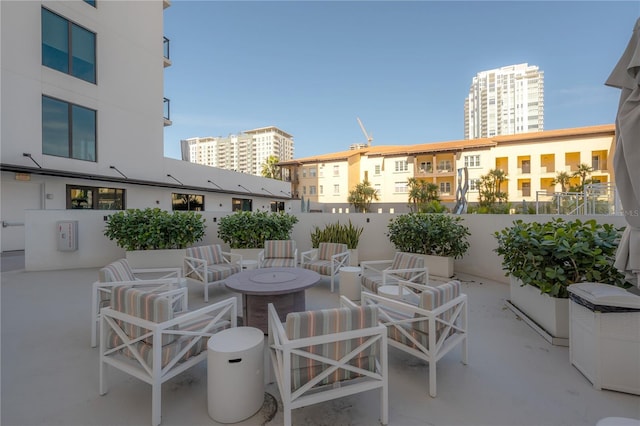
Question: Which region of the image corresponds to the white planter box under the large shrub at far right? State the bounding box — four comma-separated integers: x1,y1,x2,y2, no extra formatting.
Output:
510,277,569,345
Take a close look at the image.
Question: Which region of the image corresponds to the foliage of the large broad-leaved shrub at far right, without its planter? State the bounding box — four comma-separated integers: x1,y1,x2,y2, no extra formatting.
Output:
494,218,626,298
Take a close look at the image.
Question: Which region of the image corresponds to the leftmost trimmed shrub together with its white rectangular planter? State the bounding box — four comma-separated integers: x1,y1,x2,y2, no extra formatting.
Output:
104,207,206,268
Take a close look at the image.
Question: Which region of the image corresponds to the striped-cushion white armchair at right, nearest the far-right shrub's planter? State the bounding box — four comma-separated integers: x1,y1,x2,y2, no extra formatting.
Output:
351,280,468,397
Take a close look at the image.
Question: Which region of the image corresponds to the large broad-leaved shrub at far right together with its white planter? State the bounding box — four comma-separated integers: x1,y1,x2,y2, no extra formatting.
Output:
494,218,625,344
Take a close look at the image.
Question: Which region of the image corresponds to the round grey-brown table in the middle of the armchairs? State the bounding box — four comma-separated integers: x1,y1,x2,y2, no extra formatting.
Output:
225,268,321,334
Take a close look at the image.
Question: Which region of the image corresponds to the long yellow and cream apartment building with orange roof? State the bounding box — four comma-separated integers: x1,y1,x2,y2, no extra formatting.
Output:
279,124,615,211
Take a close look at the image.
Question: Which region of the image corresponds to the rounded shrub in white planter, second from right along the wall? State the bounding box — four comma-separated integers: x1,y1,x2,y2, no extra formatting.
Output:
387,212,470,278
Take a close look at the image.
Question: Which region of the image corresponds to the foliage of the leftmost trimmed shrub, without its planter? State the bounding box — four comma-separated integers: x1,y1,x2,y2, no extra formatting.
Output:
104,207,206,251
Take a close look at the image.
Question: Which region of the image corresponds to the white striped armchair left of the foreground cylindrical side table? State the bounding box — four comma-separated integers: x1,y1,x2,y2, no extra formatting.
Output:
100,286,237,426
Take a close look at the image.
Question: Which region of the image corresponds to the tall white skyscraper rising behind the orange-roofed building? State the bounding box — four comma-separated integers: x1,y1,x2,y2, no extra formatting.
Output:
464,64,544,139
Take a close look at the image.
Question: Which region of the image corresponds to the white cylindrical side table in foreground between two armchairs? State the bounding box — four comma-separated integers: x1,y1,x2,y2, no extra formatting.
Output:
207,327,264,423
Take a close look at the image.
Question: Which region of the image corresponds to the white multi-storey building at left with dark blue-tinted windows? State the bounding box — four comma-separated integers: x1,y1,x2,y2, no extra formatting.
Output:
0,0,289,253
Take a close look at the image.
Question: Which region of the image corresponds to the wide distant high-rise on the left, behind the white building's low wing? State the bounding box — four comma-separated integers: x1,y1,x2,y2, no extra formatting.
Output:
183,126,293,176
